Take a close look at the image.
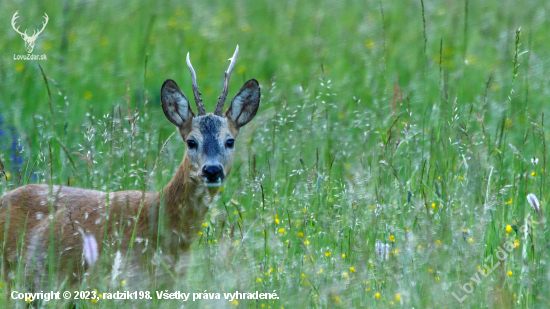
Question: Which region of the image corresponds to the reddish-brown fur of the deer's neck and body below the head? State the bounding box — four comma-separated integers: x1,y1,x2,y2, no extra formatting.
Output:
0,125,238,286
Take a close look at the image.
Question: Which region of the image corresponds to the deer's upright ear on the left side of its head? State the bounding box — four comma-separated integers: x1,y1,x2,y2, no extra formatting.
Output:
160,79,195,128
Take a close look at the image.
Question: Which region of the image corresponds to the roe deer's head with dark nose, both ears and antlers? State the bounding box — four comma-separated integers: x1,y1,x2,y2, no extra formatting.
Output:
161,46,260,189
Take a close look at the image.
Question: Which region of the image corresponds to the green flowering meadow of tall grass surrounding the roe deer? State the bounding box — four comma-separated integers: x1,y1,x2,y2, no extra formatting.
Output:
0,0,550,308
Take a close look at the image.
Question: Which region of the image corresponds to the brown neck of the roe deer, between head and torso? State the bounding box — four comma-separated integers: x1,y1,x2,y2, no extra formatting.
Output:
162,153,218,246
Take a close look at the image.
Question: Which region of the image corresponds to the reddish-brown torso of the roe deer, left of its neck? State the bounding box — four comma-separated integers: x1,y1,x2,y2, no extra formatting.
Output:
0,185,158,280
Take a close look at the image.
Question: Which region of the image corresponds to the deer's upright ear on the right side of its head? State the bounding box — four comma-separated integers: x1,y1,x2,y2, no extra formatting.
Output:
225,79,261,128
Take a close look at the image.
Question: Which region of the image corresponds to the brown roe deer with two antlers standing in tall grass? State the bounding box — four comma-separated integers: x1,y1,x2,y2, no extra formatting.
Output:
0,45,260,288
